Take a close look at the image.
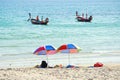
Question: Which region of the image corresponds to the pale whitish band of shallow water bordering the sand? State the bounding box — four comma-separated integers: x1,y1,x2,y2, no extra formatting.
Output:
0,52,120,69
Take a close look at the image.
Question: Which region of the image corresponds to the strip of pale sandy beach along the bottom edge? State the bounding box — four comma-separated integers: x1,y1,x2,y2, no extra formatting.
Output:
0,64,120,80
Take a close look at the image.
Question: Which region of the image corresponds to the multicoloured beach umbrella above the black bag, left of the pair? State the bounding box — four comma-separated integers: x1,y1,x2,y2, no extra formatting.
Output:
33,45,56,62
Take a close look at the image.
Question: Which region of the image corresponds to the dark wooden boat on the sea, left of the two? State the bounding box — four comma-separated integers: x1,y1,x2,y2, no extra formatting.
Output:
27,13,49,25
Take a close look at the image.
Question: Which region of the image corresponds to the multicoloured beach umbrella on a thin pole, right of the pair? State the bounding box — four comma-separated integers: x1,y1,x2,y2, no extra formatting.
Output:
57,44,80,64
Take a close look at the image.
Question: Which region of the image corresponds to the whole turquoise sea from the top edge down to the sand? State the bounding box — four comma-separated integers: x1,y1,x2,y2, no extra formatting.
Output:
0,0,120,68
